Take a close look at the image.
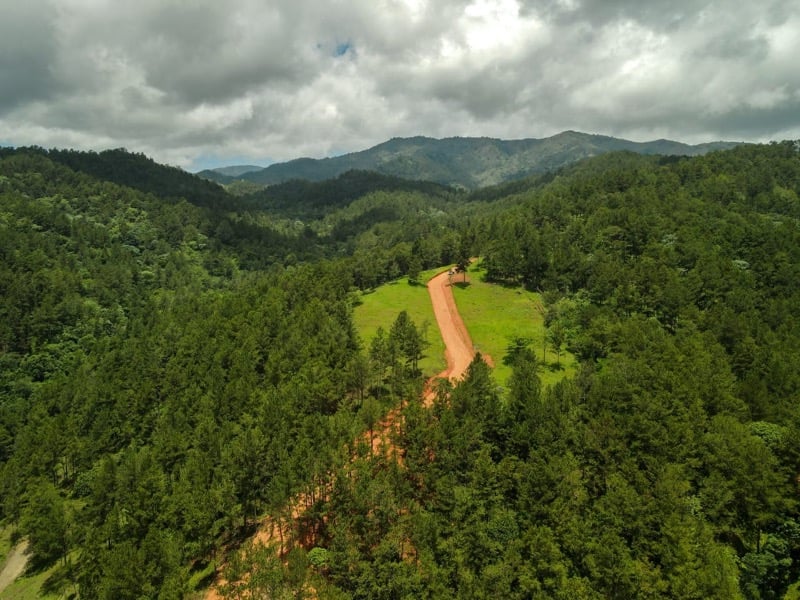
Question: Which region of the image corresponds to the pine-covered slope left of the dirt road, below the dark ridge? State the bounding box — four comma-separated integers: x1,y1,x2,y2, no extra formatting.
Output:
0,149,434,599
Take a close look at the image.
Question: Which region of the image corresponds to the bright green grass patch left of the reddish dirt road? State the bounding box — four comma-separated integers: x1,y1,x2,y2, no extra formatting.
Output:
354,269,447,376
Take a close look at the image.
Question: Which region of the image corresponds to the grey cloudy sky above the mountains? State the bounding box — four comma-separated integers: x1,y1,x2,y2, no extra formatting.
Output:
0,0,800,169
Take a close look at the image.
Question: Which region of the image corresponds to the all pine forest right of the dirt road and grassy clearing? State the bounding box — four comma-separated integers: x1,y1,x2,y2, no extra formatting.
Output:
217,143,800,599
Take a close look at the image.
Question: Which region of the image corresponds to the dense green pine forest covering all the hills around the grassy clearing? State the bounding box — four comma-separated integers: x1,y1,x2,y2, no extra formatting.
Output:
0,142,800,600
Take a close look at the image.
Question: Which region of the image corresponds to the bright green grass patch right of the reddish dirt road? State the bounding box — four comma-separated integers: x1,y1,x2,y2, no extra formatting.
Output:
453,262,576,387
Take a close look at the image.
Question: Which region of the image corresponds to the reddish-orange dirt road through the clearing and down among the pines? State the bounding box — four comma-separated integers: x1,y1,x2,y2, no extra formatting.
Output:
205,271,482,600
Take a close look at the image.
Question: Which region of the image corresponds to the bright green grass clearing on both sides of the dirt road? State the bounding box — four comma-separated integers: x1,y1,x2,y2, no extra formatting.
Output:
354,262,576,387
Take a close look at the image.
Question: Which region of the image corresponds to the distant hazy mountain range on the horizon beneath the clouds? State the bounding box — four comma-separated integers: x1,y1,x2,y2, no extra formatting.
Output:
198,131,739,189
